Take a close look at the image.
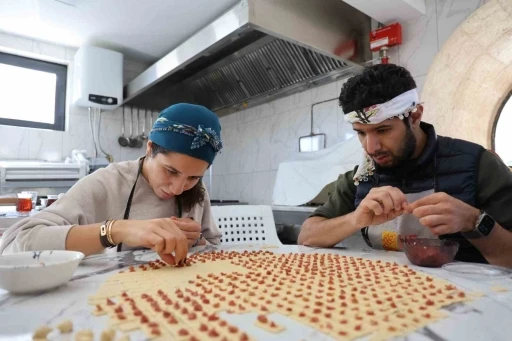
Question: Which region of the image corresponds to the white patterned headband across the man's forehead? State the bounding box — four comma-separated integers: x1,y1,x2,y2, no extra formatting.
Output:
346,89,419,124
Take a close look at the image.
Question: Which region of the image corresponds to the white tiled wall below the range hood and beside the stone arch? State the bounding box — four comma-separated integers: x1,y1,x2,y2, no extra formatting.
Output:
211,0,485,204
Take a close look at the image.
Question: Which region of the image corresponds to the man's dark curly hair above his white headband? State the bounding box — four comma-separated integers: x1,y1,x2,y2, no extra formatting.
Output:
339,64,416,113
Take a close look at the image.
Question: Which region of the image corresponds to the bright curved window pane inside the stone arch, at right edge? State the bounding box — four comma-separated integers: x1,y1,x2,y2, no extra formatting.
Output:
493,94,512,166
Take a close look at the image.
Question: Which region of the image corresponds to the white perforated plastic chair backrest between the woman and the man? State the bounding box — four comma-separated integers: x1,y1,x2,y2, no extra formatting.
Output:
212,205,281,245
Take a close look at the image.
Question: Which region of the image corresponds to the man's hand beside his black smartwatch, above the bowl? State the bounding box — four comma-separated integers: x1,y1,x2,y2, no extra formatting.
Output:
407,193,480,235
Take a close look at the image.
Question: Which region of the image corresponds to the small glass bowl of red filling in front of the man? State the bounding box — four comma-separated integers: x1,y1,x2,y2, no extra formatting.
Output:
401,238,459,268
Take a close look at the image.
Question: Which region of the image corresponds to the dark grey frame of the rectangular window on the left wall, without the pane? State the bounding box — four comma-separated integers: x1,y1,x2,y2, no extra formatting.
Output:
0,51,68,131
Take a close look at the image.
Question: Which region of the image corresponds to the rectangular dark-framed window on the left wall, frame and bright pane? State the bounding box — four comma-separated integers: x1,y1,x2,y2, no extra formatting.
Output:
0,52,67,131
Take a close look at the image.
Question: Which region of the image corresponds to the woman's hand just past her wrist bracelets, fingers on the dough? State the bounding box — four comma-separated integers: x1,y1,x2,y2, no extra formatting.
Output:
112,218,188,265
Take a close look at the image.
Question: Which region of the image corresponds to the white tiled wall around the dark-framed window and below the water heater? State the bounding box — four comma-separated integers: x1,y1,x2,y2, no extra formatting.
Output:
0,32,147,161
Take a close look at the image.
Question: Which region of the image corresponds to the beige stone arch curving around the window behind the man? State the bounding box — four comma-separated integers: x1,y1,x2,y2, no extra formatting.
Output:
421,0,512,149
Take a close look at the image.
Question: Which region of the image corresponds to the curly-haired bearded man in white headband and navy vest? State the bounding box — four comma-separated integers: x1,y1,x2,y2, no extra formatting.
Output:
298,64,512,267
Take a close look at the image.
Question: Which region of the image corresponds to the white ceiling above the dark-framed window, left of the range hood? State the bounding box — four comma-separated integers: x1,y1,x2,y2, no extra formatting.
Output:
0,0,238,63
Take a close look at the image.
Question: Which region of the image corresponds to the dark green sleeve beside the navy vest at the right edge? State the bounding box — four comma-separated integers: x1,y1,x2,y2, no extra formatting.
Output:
477,151,512,230
